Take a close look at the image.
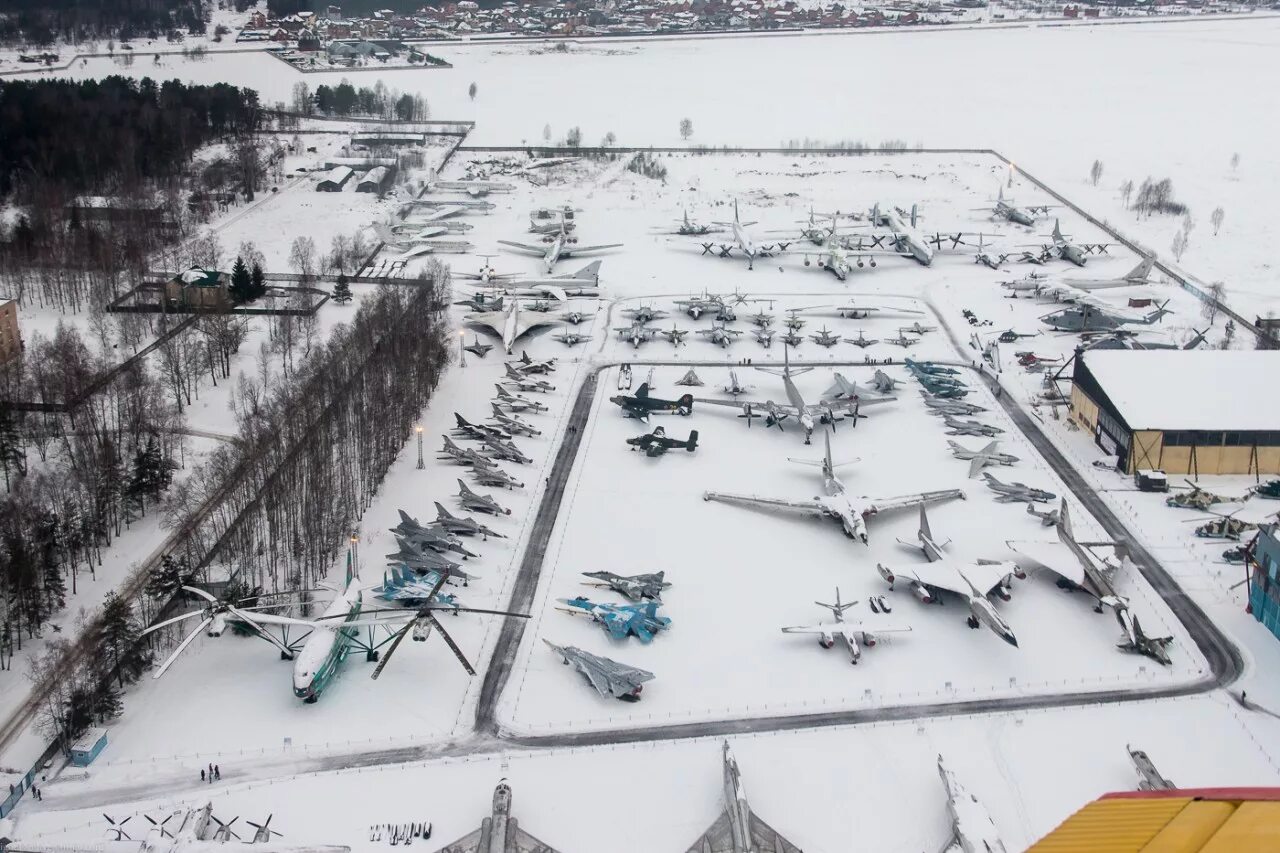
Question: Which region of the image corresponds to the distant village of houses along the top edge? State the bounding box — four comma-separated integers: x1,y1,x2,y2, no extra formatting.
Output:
238,0,1235,47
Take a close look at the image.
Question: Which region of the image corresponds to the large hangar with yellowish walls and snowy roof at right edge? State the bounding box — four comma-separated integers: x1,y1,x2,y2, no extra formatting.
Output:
1071,350,1280,476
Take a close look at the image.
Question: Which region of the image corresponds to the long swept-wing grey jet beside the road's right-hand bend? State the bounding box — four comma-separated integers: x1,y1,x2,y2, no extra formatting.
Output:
1006,498,1174,665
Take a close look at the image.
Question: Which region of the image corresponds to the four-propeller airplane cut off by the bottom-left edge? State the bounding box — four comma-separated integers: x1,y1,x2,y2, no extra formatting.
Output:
5,803,351,853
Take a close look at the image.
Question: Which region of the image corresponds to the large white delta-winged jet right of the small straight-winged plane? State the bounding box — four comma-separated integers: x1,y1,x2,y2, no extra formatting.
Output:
876,505,1025,647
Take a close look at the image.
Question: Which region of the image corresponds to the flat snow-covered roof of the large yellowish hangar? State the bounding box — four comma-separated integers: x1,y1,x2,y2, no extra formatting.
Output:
1080,350,1280,432
